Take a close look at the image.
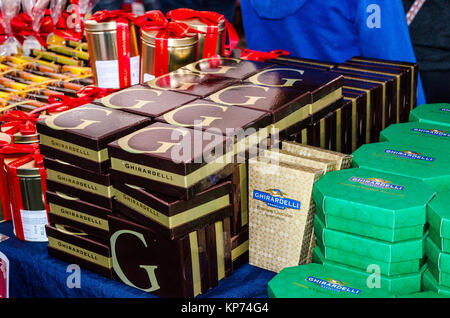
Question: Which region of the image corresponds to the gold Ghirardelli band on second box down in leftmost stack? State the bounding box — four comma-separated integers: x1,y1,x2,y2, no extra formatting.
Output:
47,169,112,198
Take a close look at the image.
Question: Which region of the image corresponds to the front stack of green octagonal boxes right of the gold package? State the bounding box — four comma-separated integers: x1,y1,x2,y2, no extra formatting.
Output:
313,168,435,295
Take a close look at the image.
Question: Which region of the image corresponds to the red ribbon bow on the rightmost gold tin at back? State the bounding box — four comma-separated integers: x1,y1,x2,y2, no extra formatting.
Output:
167,8,239,58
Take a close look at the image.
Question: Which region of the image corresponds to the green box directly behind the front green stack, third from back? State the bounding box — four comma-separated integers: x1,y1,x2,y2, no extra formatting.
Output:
353,142,450,191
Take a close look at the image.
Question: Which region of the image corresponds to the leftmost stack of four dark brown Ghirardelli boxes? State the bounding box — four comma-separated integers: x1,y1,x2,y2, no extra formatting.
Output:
37,104,150,277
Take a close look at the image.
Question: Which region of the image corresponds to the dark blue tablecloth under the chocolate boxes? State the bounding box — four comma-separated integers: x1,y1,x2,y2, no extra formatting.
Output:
0,222,275,298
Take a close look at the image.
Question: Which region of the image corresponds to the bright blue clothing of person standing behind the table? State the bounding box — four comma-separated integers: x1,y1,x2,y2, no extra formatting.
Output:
241,0,425,105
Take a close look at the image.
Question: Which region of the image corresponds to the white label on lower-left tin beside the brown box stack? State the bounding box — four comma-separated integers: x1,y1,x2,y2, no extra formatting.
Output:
20,210,48,242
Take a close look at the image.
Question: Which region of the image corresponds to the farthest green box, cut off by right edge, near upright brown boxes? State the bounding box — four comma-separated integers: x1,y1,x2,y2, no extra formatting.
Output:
409,103,450,126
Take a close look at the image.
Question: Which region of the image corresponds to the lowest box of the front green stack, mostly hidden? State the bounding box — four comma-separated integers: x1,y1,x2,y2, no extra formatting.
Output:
313,246,427,295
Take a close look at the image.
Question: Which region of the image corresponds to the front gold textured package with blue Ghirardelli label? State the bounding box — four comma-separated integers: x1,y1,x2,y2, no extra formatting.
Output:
249,157,323,272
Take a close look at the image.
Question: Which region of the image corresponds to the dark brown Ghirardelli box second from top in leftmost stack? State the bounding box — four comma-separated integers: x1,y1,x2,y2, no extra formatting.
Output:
44,157,113,209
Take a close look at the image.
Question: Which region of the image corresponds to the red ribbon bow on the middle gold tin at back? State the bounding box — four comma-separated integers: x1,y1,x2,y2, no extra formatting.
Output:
137,10,203,77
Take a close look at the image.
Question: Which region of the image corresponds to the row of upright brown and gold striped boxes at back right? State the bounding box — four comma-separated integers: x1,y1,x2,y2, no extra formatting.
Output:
271,57,418,153
